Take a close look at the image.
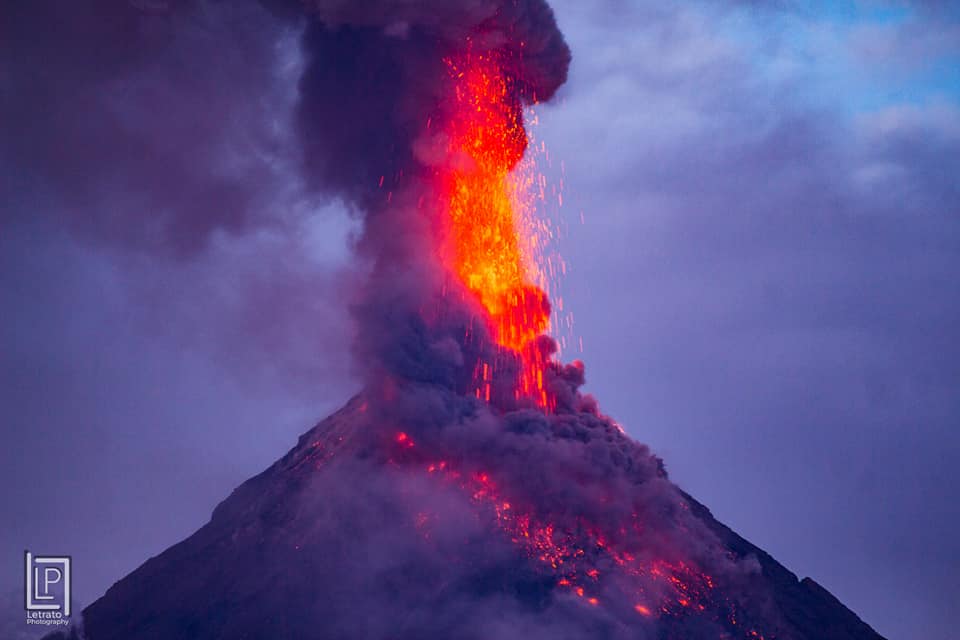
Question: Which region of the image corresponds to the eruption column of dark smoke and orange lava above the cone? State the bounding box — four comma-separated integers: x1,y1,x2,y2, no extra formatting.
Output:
278,1,576,406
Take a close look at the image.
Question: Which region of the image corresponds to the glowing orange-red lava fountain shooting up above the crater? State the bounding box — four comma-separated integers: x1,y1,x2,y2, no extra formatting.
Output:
441,54,553,408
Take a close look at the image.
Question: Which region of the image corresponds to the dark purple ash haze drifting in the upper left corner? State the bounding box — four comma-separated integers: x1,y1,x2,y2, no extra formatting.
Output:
0,0,297,256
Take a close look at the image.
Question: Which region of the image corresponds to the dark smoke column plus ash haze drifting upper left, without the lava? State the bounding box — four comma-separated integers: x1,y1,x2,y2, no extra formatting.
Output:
0,0,570,396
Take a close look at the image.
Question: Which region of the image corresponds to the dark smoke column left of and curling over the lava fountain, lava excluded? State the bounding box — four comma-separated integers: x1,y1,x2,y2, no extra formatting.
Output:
262,0,570,398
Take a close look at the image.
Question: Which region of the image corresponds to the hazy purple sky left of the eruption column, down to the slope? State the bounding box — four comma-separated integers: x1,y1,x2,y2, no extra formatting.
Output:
0,0,357,608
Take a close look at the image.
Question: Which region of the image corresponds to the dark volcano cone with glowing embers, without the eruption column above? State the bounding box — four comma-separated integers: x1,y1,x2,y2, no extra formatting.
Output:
48,385,880,640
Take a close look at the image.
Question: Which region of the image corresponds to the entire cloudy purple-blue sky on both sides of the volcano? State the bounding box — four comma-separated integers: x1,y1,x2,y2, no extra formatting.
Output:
0,0,960,640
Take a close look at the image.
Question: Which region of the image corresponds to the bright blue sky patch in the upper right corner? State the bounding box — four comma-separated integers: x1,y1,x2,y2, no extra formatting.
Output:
721,2,960,116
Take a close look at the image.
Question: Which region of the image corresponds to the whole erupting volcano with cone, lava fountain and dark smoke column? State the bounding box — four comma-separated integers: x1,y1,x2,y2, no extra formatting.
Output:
45,0,879,640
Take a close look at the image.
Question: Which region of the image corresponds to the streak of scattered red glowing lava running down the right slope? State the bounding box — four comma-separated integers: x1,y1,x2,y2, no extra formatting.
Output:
392,432,773,640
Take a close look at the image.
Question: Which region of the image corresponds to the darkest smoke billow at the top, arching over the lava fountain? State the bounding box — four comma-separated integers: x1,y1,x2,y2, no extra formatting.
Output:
284,0,570,208
